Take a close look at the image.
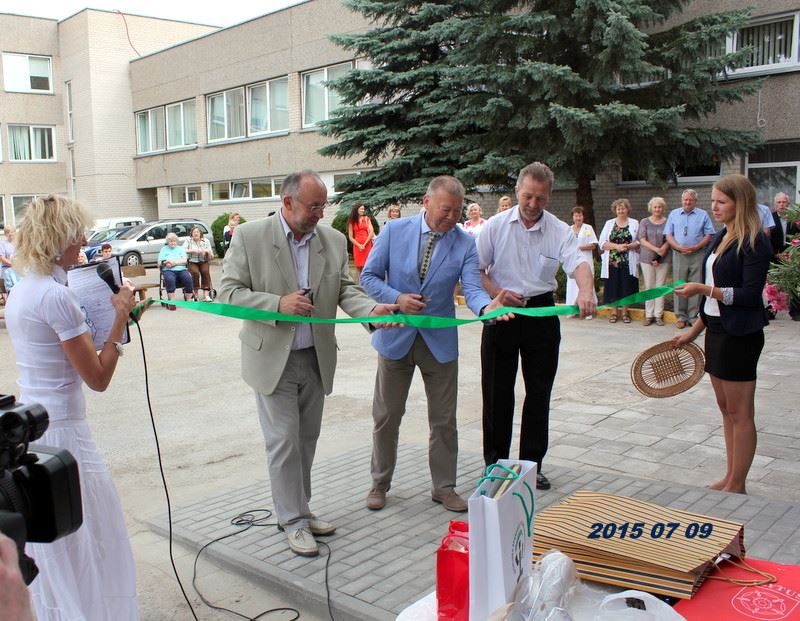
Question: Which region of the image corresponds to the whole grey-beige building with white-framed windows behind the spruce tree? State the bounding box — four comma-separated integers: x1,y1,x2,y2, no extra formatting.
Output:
0,0,800,231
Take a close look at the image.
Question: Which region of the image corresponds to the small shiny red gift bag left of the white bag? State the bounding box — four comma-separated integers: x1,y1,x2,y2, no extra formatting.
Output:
436,528,469,621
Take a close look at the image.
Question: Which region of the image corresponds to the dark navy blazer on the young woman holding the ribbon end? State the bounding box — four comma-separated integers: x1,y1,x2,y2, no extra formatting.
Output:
700,227,772,336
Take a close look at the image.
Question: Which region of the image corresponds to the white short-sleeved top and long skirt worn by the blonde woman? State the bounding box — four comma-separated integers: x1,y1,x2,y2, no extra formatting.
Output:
6,267,139,621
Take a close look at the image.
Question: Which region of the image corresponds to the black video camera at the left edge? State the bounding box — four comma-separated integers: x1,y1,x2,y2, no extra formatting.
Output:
0,395,83,584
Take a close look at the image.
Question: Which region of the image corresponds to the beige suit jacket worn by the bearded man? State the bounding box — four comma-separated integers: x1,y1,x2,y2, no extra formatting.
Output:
219,214,375,395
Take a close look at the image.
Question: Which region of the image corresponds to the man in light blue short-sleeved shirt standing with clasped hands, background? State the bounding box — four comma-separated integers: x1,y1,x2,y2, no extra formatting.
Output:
664,190,714,330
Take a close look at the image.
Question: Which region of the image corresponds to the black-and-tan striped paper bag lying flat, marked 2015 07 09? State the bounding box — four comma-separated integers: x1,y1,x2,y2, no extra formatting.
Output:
533,490,745,599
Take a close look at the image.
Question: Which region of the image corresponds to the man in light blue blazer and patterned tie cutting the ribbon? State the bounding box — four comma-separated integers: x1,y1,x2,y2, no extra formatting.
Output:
361,176,506,512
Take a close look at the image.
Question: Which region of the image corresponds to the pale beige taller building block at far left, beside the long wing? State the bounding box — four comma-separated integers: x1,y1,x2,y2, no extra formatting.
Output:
0,9,217,230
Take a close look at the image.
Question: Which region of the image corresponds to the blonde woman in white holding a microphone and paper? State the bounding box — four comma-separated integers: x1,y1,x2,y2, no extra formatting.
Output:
6,195,139,621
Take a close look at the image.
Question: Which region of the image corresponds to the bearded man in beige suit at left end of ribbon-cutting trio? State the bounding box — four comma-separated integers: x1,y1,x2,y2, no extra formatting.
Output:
220,170,397,556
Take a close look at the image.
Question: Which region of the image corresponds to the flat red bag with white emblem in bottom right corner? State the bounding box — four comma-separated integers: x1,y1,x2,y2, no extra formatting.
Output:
675,558,800,621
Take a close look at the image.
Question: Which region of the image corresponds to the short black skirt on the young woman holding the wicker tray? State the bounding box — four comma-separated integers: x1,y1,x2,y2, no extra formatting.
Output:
703,315,764,382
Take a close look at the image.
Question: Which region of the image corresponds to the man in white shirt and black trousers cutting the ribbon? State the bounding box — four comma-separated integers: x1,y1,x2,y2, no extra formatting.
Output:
477,162,596,489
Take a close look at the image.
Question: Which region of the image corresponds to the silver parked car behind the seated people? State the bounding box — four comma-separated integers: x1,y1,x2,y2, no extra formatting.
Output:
108,218,214,265
